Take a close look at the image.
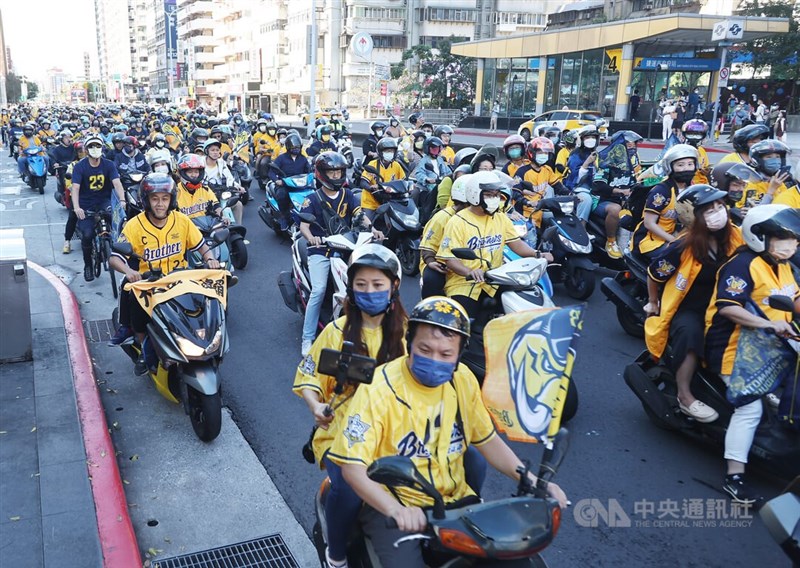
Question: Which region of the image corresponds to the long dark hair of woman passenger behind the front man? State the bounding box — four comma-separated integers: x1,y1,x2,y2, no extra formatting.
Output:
342,273,408,365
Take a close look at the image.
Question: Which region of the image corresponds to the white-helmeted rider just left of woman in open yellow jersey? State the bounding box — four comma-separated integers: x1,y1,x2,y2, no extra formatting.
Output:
633,144,699,259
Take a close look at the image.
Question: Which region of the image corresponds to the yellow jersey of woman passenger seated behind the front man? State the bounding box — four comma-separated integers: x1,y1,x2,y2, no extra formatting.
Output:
292,316,398,467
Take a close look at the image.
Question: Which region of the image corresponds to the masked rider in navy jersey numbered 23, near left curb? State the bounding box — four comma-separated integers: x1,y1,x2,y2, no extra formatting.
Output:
71,136,125,282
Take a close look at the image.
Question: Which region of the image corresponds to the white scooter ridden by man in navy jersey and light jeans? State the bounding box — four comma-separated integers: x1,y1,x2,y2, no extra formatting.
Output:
278,221,373,338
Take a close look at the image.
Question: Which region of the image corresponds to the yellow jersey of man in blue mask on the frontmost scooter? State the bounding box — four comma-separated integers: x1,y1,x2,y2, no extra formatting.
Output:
328,356,496,507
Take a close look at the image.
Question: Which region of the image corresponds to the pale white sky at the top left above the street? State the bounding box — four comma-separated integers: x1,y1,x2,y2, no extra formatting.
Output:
0,0,97,80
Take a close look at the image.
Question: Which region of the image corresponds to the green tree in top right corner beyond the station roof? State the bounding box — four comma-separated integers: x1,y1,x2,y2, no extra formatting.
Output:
737,0,800,111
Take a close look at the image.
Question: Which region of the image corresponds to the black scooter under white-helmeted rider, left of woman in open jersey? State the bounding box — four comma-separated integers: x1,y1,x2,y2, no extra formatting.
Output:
600,249,650,338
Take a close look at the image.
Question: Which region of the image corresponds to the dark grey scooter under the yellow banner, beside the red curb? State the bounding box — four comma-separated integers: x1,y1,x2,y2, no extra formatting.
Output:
108,237,232,442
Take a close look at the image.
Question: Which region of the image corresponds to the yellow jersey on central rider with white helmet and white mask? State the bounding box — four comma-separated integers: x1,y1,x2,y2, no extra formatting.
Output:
436,208,519,299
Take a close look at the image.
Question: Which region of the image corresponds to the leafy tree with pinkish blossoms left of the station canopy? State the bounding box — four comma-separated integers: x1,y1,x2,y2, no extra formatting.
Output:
392,36,477,108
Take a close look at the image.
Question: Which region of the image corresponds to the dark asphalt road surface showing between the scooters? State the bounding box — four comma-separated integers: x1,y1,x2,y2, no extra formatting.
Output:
220,150,785,567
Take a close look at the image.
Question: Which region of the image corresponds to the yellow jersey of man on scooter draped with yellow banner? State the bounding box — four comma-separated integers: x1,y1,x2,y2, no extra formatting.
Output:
114,211,204,274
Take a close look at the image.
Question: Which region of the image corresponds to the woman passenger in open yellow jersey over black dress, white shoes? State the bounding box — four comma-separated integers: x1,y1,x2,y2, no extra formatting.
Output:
644,184,744,422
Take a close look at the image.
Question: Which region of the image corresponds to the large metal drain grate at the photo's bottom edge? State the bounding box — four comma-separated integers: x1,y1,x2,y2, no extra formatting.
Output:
153,534,299,568
